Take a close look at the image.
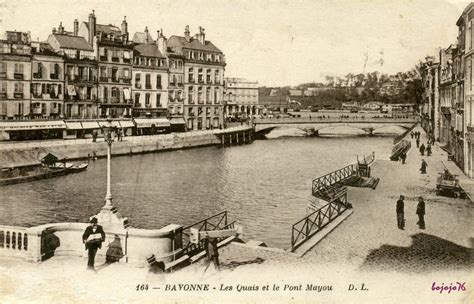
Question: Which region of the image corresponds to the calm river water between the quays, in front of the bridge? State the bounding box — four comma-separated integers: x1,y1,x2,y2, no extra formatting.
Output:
0,133,393,248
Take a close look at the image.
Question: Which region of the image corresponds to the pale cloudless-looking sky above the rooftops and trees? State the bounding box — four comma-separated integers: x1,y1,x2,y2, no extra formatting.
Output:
0,0,468,85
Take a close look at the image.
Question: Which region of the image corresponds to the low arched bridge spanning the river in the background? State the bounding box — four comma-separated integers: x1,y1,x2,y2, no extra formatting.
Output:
254,117,417,135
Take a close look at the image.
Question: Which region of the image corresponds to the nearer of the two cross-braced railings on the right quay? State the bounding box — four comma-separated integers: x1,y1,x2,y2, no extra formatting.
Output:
291,188,350,252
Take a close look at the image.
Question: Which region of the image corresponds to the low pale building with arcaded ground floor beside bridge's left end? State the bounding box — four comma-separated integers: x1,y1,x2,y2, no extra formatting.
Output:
224,78,259,117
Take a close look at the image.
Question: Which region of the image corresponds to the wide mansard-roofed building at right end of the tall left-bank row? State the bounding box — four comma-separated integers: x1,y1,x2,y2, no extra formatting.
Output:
168,26,225,130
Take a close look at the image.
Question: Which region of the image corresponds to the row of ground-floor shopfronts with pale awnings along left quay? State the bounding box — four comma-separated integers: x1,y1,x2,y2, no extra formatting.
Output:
0,117,186,141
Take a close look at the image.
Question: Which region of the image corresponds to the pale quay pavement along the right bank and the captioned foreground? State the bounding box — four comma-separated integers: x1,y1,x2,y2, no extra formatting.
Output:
0,128,474,303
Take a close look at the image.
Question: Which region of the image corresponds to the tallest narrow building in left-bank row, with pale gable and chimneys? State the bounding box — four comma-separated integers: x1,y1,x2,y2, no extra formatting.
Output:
78,12,133,117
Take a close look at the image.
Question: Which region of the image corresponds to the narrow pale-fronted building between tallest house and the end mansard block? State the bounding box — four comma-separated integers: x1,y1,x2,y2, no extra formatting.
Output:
132,30,168,117
